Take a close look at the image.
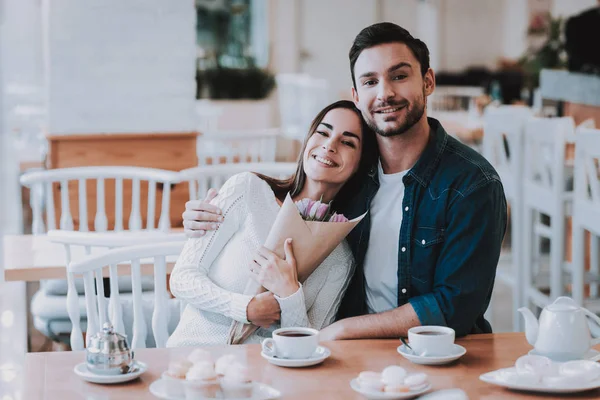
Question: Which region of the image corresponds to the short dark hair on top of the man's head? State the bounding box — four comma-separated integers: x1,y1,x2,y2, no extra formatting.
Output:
348,22,429,88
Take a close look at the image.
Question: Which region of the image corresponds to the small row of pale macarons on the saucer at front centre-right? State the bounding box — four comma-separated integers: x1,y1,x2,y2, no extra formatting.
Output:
357,365,429,393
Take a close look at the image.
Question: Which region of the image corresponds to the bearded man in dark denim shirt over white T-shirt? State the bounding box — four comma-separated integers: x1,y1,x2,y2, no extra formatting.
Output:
184,23,507,340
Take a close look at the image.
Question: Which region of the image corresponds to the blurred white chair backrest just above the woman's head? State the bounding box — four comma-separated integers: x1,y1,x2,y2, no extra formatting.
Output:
275,73,330,140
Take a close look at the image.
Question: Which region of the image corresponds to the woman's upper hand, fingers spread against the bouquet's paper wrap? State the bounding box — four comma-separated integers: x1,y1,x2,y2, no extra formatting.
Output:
250,239,300,297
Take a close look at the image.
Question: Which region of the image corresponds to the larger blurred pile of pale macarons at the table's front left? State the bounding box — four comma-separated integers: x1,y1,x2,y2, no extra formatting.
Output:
162,349,253,400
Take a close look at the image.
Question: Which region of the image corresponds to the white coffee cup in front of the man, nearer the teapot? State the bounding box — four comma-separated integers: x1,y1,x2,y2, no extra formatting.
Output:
408,325,455,357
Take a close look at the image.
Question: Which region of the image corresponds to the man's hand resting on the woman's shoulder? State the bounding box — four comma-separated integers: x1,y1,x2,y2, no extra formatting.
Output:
182,189,223,238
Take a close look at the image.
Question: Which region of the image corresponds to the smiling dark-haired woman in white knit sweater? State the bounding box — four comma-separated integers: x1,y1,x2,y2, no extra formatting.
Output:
167,100,376,347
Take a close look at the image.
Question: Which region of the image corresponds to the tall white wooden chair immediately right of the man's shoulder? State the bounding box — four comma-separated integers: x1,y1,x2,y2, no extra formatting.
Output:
483,106,532,331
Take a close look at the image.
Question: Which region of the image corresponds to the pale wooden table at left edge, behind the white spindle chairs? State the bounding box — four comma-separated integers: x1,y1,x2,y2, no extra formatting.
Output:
2,229,181,282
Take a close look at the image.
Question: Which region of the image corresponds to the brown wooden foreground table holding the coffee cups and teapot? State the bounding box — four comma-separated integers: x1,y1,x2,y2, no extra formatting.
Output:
23,333,600,400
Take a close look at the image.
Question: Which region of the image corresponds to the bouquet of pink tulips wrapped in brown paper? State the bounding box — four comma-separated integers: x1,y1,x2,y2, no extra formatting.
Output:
229,194,364,344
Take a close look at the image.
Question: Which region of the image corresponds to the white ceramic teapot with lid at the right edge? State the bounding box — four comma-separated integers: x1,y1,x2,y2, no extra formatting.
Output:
517,297,600,361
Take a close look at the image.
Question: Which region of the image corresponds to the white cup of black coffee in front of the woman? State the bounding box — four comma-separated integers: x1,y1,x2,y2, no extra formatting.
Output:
262,328,319,359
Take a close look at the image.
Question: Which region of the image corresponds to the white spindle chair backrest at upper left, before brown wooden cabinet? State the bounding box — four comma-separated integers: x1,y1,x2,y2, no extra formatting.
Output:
21,166,177,234
